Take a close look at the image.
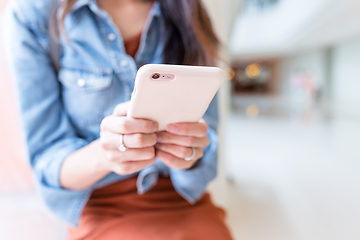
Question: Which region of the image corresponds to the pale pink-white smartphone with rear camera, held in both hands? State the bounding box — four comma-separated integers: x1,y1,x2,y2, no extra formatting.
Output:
128,64,225,131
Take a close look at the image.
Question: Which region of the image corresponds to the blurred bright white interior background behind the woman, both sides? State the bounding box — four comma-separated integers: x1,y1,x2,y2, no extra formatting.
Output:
0,0,360,240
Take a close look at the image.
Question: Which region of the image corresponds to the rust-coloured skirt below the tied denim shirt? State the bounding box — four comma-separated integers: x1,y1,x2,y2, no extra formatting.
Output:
68,177,232,240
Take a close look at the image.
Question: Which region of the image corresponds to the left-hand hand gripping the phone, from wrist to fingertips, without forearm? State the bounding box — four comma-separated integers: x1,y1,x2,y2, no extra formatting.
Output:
100,102,158,175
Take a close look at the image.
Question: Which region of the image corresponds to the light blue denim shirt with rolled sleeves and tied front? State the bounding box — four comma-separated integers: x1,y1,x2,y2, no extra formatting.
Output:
3,0,218,226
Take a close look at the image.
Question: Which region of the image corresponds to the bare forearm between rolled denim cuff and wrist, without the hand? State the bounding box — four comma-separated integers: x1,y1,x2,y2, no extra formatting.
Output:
60,140,111,190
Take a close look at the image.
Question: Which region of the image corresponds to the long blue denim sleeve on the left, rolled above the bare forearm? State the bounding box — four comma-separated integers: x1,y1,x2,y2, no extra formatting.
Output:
3,1,88,191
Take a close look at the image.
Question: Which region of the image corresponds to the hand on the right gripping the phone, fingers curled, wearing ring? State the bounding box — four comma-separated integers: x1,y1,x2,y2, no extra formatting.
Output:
155,119,210,169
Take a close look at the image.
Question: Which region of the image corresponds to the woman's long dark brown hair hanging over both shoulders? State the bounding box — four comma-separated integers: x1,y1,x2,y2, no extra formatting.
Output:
52,0,220,65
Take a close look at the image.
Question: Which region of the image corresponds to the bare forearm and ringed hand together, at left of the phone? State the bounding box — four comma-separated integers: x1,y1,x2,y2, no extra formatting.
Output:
60,102,158,190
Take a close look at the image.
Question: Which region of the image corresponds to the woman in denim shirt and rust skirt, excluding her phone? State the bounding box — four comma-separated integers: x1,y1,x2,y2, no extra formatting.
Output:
4,0,231,239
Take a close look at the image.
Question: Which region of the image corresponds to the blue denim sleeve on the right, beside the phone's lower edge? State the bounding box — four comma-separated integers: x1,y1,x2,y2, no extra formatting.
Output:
169,93,219,204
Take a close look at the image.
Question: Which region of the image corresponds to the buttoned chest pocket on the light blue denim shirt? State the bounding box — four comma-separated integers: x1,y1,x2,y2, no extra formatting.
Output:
59,65,113,128
